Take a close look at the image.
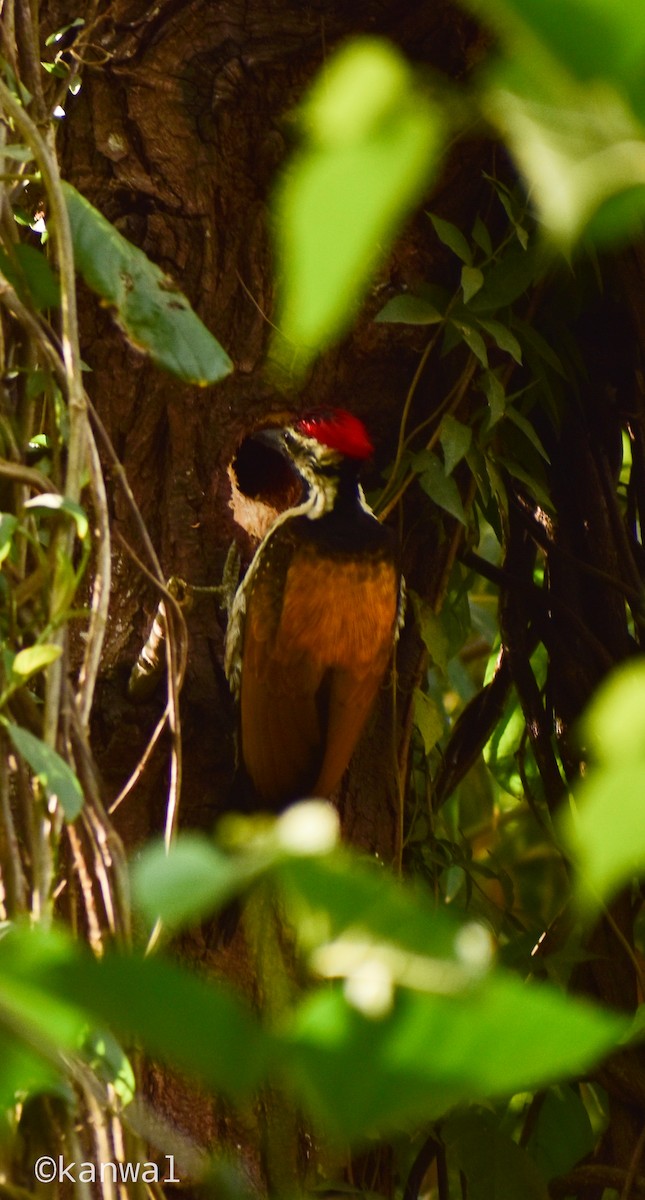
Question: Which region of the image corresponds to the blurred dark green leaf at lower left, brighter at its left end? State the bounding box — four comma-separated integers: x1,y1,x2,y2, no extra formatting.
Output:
0,930,266,1099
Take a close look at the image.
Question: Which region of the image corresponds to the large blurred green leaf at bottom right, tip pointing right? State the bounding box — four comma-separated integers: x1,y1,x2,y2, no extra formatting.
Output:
283,971,626,1140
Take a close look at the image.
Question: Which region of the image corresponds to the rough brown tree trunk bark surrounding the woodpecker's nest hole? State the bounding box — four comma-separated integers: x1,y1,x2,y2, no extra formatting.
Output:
36,0,488,1194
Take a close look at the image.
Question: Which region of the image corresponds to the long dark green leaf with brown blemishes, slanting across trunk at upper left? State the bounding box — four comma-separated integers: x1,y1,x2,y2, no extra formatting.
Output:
64,184,233,386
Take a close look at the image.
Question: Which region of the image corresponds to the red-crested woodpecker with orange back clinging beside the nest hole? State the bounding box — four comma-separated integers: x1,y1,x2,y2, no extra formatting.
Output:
225,409,402,810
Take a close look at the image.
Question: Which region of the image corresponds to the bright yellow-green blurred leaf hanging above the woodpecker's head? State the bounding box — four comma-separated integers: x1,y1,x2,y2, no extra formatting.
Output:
273,38,442,360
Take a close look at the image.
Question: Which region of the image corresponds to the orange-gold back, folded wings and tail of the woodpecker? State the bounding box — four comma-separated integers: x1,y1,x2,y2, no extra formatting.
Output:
241,546,398,805
